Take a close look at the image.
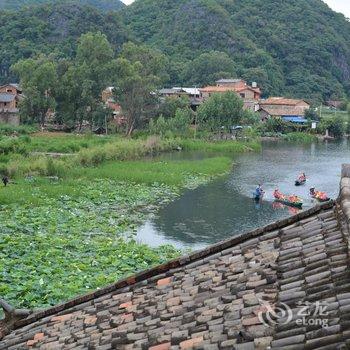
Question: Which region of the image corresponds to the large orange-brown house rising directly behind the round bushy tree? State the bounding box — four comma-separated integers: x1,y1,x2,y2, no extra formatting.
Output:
199,79,261,111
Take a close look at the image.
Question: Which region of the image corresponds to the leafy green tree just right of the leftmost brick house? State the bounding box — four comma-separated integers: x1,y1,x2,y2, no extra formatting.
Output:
12,55,58,126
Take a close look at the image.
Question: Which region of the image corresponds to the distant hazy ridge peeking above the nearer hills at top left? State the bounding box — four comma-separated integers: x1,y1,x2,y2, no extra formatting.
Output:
0,0,125,11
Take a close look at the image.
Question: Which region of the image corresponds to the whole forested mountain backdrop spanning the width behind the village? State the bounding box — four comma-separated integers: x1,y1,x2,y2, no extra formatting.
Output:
0,0,350,101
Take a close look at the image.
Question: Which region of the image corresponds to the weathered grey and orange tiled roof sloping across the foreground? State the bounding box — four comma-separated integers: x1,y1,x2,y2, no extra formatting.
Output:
0,196,350,350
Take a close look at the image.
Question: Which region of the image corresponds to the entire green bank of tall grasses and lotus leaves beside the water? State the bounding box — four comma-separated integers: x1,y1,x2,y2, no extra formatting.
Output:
0,132,259,308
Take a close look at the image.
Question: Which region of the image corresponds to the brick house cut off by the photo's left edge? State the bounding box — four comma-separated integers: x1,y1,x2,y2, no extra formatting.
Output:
0,84,22,125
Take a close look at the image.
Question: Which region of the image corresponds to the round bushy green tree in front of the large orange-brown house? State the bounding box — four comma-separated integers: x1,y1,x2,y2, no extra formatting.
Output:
197,91,244,131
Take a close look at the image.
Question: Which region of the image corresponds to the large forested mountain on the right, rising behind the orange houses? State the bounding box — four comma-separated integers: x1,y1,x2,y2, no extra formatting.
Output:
124,0,350,98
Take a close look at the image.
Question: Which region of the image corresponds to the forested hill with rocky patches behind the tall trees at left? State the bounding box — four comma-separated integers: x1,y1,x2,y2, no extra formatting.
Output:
0,3,128,83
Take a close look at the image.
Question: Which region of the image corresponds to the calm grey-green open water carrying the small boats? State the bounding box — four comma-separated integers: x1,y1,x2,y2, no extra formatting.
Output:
137,140,350,250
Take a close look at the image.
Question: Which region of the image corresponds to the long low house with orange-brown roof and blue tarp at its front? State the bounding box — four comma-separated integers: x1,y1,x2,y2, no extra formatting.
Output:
257,97,310,124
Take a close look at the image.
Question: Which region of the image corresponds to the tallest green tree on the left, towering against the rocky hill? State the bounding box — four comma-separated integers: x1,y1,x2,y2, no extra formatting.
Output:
57,32,114,129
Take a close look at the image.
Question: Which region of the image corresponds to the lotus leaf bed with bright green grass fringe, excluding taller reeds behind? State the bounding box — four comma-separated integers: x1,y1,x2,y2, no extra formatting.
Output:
0,152,232,308
